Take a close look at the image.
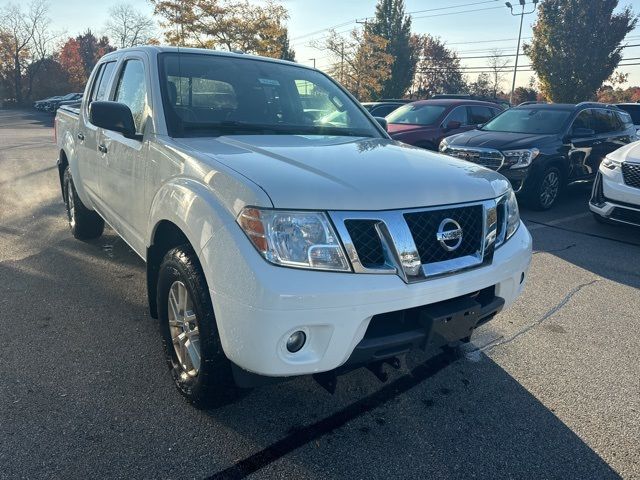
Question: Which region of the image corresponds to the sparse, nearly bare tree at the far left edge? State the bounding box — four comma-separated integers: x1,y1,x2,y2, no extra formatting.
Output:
0,0,49,103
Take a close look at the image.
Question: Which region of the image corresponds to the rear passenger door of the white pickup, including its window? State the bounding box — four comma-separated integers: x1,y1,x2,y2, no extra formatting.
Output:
76,61,116,204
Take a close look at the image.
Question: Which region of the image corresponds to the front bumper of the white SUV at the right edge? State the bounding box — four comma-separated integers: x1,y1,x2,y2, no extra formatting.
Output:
589,166,640,226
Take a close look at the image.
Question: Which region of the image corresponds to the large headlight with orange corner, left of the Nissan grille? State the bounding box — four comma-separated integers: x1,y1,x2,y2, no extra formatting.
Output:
238,207,351,272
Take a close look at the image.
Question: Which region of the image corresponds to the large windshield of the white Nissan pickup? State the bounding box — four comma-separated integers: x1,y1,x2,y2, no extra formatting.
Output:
160,53,381,137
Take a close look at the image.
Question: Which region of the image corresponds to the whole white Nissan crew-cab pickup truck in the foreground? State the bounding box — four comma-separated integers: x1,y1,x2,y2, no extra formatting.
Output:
55,47,531,406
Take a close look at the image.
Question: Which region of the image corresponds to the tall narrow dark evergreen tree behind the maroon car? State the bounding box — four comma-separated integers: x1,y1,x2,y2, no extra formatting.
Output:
367,0,419,98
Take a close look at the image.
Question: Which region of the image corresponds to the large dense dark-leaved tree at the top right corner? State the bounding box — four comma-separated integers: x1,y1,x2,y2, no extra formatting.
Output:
524,0,637,103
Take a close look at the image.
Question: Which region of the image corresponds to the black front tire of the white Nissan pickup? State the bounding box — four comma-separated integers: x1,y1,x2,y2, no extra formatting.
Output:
157,245,240,408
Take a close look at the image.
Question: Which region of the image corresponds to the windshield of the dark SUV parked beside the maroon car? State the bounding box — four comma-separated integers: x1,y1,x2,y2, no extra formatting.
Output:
480,108,572,135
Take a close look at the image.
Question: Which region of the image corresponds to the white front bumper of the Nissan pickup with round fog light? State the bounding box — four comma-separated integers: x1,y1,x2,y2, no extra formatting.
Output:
200,224,531,376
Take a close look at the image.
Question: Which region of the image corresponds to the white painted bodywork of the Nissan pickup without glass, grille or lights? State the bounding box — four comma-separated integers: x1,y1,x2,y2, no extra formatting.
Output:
58,47,531,375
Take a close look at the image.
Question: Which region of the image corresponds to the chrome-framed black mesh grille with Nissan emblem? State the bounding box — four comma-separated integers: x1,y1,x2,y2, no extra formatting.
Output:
329,197,506,283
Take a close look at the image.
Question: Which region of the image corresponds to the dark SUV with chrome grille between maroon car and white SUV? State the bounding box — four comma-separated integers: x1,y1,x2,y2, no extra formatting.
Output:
440,102,637,210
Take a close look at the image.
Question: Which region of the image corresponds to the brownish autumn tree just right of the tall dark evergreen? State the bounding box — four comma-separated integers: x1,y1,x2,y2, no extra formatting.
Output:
413,34,467,98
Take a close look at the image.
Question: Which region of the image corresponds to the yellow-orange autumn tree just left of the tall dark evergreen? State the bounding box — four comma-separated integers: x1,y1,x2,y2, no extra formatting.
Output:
313,29,393,101
